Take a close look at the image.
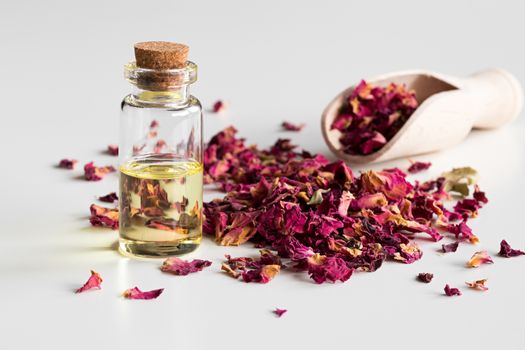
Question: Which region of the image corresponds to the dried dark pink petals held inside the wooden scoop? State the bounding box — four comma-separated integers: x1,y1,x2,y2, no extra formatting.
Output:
331,80,418,155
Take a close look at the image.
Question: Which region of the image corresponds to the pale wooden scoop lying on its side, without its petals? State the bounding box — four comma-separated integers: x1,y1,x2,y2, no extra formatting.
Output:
321,69,523,163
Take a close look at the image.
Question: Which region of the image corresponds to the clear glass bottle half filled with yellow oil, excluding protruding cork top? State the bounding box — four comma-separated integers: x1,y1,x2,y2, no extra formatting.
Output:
119,43,203,257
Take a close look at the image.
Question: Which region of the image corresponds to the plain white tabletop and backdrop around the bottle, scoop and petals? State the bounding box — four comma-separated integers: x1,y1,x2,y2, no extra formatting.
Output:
0,1,525,350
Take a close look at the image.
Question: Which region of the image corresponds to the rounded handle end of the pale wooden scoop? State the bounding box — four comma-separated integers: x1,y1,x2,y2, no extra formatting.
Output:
458,69,523,129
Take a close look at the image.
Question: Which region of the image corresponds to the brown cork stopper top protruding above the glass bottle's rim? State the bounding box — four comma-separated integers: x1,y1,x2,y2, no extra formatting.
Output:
135,41,190,70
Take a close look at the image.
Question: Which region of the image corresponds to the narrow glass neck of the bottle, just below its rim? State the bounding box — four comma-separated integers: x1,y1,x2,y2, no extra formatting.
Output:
131,85,190,108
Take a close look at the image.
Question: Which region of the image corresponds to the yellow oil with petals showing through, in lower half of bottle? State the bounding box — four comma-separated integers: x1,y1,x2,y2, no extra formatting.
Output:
119,155,203,257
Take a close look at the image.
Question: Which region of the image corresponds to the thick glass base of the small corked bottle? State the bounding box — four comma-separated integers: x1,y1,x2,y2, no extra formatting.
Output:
118,238,201,258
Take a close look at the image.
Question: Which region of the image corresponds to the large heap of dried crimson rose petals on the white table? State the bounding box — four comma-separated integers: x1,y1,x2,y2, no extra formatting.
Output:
203,127,487,283
